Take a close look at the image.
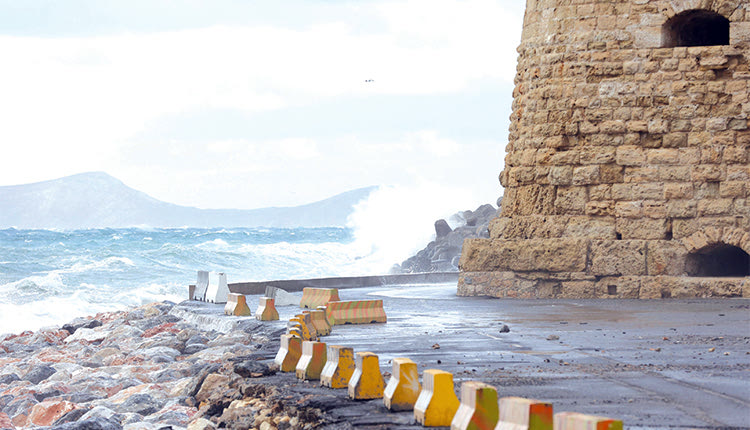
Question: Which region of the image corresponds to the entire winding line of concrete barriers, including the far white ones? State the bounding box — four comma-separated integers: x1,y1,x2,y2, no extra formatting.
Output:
191,280,623,430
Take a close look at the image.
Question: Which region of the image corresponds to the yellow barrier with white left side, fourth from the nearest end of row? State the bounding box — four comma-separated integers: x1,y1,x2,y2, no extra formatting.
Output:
414,369,459,427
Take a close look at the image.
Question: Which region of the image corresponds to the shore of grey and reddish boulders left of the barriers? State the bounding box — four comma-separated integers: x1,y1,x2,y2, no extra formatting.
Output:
0,302,378,430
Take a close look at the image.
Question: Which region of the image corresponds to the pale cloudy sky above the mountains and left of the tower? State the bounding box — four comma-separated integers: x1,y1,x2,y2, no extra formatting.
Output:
0,0,525,211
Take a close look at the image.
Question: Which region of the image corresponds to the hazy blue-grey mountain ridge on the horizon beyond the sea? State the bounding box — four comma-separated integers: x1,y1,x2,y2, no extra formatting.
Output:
0,172,377,229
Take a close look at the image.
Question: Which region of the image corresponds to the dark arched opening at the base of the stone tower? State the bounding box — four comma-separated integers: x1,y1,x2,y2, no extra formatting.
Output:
687,244,750,277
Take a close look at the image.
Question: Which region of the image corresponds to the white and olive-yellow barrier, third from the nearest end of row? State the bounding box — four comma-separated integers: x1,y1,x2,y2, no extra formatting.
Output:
451,381,499,430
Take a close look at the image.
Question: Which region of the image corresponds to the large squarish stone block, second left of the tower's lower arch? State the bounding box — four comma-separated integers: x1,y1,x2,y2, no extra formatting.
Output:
589,240,646,276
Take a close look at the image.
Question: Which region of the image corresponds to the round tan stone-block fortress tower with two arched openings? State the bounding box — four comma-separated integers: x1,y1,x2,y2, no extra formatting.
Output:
458,0,750,298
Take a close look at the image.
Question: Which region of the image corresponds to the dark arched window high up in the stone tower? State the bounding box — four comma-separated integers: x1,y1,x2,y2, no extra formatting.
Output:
662,9,729,48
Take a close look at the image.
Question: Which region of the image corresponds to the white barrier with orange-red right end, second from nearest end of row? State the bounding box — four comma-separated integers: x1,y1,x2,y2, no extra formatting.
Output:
495,397,553,430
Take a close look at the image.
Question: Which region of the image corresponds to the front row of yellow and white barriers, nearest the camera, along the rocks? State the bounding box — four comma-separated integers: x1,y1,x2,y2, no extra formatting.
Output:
274,333,623,430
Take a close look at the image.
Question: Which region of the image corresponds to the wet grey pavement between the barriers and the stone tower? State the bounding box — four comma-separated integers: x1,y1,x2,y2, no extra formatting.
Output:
222,283,750,429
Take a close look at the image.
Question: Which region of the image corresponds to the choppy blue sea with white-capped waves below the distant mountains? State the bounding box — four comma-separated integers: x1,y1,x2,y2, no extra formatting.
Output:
0,224,412,334
